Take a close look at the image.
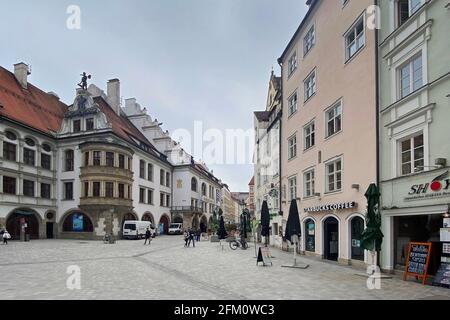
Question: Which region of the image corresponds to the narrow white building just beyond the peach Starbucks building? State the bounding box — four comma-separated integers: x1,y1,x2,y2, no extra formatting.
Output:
254,71,283,248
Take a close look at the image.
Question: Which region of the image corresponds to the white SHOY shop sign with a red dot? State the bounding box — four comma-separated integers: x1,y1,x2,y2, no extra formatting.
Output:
405,171,450,201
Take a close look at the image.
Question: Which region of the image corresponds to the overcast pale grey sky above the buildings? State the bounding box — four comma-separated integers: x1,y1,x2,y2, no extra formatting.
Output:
0,0,307,191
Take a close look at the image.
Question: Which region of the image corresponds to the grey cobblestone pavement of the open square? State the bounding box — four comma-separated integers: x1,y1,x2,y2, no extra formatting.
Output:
0,236,450,300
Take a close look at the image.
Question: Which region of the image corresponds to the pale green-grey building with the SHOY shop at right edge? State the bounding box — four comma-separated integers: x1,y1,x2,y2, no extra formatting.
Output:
379,0,450,274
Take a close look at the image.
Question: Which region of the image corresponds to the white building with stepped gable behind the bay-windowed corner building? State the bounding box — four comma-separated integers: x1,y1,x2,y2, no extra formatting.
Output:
124,98,223,232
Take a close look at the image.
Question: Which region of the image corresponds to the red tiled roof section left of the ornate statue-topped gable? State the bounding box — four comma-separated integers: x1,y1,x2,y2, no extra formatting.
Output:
0,67,67,133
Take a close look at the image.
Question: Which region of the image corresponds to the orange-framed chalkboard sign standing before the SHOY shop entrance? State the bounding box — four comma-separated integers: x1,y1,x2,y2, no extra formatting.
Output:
403,242,431,284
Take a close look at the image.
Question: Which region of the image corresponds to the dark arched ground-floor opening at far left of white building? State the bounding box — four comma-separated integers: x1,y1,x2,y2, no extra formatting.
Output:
5,207,42,240
